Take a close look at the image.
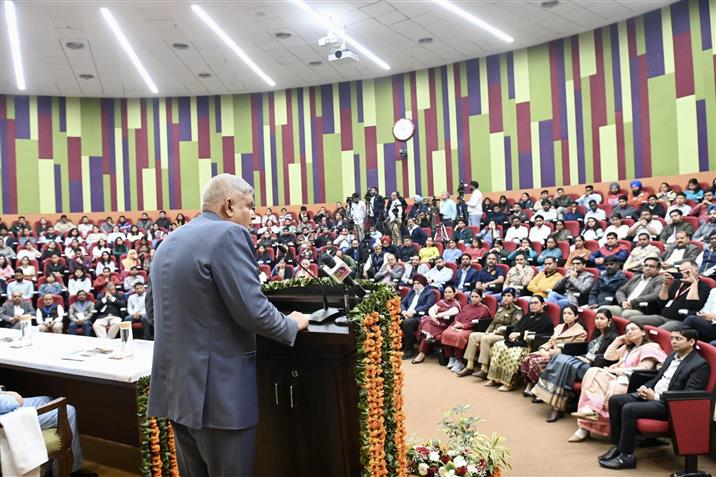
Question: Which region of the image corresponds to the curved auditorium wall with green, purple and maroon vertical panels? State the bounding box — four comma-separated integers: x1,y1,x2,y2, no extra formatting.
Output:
0,0,716,214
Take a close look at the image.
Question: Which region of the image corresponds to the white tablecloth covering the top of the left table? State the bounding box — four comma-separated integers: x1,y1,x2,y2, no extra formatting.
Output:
0,328,154,383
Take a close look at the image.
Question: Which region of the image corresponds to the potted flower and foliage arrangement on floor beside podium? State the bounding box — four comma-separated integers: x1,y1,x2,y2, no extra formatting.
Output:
407,406,510,477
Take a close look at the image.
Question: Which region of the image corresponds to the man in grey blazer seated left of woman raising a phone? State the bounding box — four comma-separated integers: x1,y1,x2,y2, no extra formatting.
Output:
599,257,664,319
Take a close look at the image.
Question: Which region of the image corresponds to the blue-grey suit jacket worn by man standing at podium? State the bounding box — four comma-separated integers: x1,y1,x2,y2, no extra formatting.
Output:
148,212,297,429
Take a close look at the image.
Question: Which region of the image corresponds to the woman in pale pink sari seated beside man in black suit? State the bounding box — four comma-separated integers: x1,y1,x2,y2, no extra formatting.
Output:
568,323,666,442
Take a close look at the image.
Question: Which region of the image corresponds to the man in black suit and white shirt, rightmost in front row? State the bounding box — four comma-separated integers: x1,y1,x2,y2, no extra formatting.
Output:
599,327,710,469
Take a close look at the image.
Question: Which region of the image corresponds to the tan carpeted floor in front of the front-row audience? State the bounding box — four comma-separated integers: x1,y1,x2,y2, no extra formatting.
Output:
403,357,716,477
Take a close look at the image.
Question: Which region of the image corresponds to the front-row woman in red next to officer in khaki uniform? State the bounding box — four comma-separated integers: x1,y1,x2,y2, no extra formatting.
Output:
440,288,492,373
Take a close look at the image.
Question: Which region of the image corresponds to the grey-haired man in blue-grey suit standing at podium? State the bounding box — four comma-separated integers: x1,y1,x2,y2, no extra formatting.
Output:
147,174,308,477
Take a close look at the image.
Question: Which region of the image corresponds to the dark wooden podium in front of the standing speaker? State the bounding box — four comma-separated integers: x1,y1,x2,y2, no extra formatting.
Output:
255,286,361,477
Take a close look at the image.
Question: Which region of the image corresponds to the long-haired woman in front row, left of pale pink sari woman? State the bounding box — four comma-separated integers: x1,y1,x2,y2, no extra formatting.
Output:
532,308,617,422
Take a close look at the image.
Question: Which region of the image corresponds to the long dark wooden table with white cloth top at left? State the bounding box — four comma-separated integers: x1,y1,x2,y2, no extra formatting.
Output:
0,328,154,472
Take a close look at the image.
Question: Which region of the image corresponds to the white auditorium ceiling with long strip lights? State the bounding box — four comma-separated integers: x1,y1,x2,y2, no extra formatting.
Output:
0,0,673,97
